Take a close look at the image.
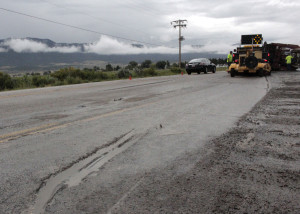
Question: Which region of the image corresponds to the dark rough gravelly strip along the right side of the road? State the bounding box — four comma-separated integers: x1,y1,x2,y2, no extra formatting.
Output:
114,72,300,213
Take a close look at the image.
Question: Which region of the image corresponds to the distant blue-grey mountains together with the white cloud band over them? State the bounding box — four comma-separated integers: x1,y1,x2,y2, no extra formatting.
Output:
0,36,225,73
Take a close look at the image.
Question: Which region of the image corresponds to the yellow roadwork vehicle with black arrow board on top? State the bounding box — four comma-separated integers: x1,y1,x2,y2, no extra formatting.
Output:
228,34,271,77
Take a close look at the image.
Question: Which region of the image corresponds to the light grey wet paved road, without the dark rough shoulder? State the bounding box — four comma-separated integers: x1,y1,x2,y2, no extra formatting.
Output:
0,72,270,213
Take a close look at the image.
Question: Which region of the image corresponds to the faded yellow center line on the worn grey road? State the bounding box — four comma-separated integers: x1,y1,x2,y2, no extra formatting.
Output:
0,101,158,143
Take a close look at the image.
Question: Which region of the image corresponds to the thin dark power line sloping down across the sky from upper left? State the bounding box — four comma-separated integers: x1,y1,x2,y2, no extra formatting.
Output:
0,7,162,47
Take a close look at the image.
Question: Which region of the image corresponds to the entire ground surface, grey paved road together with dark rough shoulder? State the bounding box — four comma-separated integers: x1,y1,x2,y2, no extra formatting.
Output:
0,72,300,213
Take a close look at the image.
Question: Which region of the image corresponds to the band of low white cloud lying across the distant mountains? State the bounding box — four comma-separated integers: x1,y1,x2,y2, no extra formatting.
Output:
0,36,233,55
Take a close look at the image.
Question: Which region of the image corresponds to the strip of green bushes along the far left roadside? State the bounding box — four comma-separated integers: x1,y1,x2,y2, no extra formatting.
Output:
0,60,224,91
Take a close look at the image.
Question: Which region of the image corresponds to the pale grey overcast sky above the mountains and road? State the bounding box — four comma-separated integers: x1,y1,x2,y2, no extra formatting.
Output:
0,0,300,54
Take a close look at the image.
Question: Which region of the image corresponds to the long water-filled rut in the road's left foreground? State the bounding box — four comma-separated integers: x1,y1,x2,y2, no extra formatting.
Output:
32,131,144,214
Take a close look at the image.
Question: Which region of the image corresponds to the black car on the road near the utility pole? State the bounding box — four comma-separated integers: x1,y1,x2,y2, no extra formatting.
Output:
185,58,216,75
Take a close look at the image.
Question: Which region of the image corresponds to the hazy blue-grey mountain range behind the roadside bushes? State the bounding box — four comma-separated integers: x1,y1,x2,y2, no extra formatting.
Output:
0,38,225,73
